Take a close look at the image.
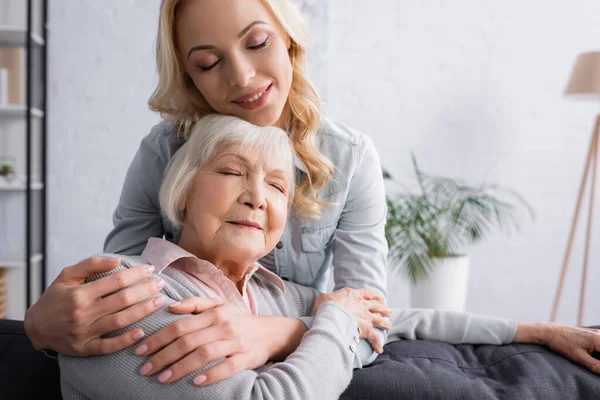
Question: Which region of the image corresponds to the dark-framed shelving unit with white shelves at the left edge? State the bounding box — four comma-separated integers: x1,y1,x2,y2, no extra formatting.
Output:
0,0,48,319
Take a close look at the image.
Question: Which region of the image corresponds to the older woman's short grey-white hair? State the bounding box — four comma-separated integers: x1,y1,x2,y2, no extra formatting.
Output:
159,114,295,228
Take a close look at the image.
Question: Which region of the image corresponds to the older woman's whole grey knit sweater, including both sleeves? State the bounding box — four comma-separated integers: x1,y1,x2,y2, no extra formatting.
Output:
59,257,516,400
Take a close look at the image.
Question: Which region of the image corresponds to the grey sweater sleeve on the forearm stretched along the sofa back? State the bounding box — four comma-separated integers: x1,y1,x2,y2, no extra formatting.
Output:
388,309,517,345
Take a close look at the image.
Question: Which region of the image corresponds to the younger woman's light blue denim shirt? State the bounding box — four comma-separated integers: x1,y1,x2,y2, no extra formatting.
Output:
104,118,388,368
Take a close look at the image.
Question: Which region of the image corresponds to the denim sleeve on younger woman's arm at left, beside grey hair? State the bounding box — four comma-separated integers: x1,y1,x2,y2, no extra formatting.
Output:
104,122,170,255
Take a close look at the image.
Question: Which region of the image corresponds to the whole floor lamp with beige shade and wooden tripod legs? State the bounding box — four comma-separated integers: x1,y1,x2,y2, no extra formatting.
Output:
550,52,600,326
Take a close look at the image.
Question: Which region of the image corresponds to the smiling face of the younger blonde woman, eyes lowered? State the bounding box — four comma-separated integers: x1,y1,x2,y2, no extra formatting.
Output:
175,0,292,127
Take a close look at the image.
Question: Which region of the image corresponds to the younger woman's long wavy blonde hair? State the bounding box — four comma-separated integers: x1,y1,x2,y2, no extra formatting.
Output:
148,0,334,219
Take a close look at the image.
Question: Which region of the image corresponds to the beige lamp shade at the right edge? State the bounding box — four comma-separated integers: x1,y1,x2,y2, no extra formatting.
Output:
565,52,600,100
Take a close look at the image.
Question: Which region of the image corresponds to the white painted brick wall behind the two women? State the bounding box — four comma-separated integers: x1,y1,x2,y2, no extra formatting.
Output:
48,0,600,323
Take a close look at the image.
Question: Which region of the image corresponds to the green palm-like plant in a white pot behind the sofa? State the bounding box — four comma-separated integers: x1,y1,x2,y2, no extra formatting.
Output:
383,155,534,311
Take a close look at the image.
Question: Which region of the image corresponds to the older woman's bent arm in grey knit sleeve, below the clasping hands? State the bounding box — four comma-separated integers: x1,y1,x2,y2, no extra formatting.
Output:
60,300,357,399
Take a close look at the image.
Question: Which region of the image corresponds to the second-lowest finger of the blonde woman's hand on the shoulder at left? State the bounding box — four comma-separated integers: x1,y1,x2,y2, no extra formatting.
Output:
90,295,164,340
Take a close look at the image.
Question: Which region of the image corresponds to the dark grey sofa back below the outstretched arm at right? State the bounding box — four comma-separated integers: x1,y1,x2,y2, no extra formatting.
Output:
341,328,600,400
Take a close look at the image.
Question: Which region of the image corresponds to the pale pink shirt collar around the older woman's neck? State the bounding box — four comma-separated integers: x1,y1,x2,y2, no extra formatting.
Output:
142,237,285,292
